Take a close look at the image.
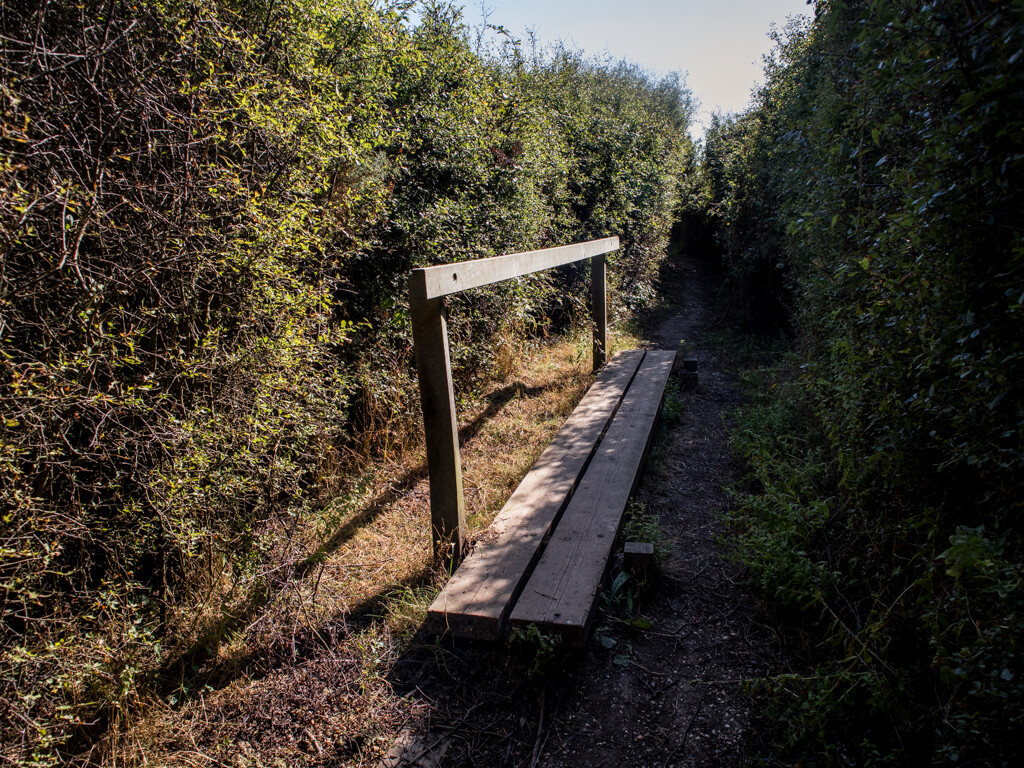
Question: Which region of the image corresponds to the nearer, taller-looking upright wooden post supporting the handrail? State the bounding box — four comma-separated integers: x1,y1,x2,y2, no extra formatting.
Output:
410,291,466,564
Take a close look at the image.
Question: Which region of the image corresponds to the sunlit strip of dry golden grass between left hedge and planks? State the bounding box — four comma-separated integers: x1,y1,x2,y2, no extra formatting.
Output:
110,325,637,768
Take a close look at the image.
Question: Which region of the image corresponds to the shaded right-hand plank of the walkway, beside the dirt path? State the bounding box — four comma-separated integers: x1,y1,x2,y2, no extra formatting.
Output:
509,350,676,645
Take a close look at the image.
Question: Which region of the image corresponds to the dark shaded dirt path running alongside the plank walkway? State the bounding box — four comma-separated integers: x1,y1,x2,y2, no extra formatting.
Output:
385,249,771,768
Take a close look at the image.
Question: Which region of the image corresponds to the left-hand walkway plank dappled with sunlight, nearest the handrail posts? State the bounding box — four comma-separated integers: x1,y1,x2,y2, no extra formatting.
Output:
427,351,643,640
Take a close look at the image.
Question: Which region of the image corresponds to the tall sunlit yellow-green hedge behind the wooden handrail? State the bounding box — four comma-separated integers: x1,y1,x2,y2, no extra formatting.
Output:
0,0,692,764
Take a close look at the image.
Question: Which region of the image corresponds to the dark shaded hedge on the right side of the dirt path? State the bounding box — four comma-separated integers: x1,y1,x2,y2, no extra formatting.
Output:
706,1,1024,765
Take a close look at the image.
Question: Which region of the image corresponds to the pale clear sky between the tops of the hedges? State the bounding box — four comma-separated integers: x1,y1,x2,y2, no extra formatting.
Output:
464,0,813,137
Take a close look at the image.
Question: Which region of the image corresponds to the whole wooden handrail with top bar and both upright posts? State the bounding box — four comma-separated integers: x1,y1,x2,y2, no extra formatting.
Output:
409,237,618,564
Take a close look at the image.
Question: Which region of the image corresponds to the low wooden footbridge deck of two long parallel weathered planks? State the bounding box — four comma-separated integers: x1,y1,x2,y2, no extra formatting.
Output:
427,350,675,643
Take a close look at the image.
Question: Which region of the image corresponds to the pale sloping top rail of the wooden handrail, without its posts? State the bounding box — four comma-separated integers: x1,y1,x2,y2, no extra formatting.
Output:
409,238,618,300
